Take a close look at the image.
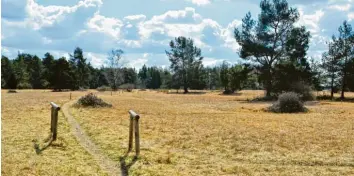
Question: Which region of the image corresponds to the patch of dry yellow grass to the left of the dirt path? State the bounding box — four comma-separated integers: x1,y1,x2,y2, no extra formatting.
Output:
1,90,106,175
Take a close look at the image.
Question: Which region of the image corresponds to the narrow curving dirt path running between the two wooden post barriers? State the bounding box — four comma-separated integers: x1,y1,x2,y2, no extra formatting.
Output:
62,101,121,175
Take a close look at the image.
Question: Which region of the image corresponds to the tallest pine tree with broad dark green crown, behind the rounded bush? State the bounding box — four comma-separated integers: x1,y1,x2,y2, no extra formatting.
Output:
234,0,310,96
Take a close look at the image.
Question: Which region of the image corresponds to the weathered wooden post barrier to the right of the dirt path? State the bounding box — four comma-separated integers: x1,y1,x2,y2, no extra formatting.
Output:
128,110,140,156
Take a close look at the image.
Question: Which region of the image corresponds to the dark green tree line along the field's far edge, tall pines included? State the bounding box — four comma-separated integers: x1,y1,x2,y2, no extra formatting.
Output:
1,0,354,98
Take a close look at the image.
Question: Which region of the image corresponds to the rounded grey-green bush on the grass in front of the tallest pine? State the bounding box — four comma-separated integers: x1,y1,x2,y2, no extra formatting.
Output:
269,92,306,113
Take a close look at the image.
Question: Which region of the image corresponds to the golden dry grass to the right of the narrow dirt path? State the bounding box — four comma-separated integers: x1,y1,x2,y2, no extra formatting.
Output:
71,91,354,175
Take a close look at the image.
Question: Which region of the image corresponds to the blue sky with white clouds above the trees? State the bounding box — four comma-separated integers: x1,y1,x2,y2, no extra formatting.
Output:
1,0,354,68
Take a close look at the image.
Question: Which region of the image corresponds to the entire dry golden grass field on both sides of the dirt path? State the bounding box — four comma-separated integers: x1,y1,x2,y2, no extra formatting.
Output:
1,90,354,175
